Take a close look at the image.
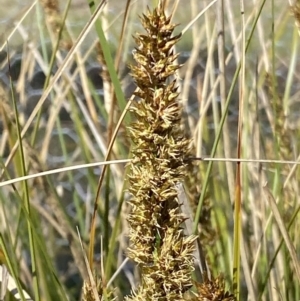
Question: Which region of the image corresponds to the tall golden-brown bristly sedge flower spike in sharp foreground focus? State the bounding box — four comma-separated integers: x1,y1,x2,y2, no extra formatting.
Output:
128,2,195,301
